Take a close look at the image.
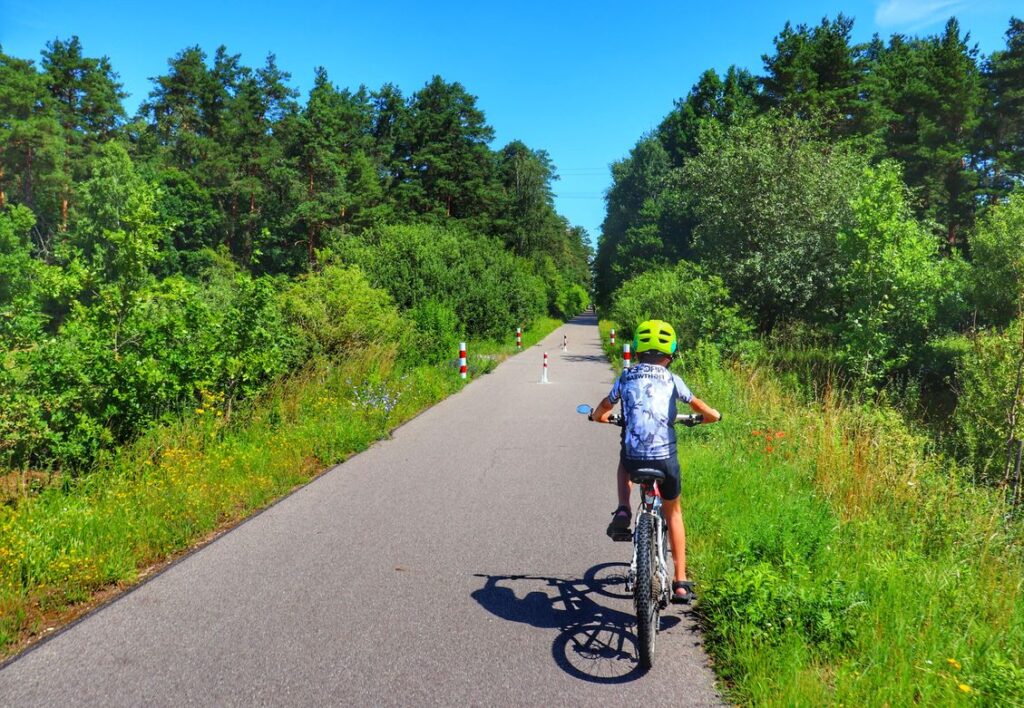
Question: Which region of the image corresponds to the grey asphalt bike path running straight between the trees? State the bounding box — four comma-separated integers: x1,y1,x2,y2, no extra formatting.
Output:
0,317,721,706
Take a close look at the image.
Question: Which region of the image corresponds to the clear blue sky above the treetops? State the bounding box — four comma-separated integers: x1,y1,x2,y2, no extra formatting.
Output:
0,0,1024,239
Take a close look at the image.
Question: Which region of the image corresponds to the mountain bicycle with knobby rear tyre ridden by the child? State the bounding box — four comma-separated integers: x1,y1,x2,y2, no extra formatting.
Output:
577,404,703,669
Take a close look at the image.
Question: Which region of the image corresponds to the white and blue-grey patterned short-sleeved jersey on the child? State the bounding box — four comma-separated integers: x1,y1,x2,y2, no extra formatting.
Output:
608,364,693,460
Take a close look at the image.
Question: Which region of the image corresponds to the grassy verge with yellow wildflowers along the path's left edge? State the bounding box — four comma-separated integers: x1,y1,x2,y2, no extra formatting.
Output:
0,319,562,656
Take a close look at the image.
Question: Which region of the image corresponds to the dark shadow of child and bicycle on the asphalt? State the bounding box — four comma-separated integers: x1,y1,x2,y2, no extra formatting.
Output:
472,563,680,683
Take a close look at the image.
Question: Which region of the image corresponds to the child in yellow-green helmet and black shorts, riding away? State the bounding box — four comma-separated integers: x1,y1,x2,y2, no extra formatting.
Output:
591,320,722,603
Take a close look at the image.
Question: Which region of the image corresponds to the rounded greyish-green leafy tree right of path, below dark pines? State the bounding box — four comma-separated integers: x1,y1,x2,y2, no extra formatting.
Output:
686,116,864,329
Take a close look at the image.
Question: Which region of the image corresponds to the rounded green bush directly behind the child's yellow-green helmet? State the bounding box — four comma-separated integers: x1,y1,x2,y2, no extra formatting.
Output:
610,260,753,361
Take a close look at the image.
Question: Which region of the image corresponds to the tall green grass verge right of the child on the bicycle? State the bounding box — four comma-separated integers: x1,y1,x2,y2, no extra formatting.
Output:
602,323,1024,706
